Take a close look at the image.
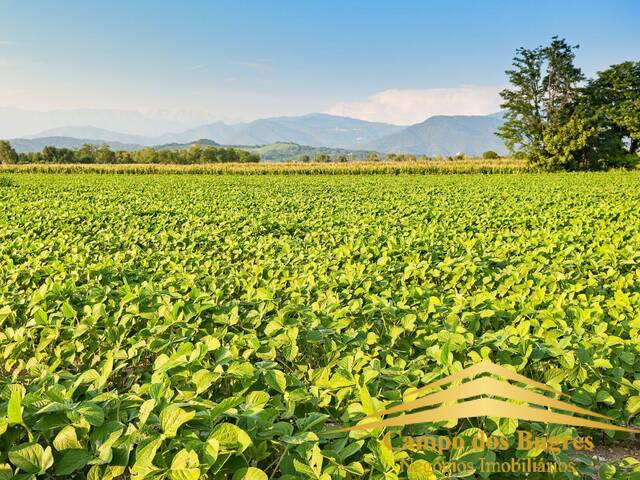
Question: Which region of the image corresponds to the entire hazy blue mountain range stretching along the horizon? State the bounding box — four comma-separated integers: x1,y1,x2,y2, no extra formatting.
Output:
0,112,505,156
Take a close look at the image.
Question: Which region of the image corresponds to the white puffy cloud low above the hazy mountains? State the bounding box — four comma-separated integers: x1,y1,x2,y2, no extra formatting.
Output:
326,85,501,125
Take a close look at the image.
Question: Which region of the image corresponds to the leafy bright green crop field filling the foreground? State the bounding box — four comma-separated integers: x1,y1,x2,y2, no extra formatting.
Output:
0,172,640,480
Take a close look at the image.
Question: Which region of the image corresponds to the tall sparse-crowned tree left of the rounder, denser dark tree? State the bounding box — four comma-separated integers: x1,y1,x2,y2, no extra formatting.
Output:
498,37,589,169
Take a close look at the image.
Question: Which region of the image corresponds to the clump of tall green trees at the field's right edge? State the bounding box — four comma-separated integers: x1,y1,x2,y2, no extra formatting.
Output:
498,37,640,170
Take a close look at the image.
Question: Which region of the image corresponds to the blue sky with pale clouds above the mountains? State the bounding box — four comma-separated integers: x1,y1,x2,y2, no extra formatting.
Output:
0,0,640,129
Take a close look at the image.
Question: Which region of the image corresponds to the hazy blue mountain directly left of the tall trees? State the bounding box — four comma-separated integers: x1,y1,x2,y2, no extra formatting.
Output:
367,114,506,155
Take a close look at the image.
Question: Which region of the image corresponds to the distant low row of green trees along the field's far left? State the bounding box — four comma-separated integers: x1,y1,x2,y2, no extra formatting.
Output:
0,141,260,165
